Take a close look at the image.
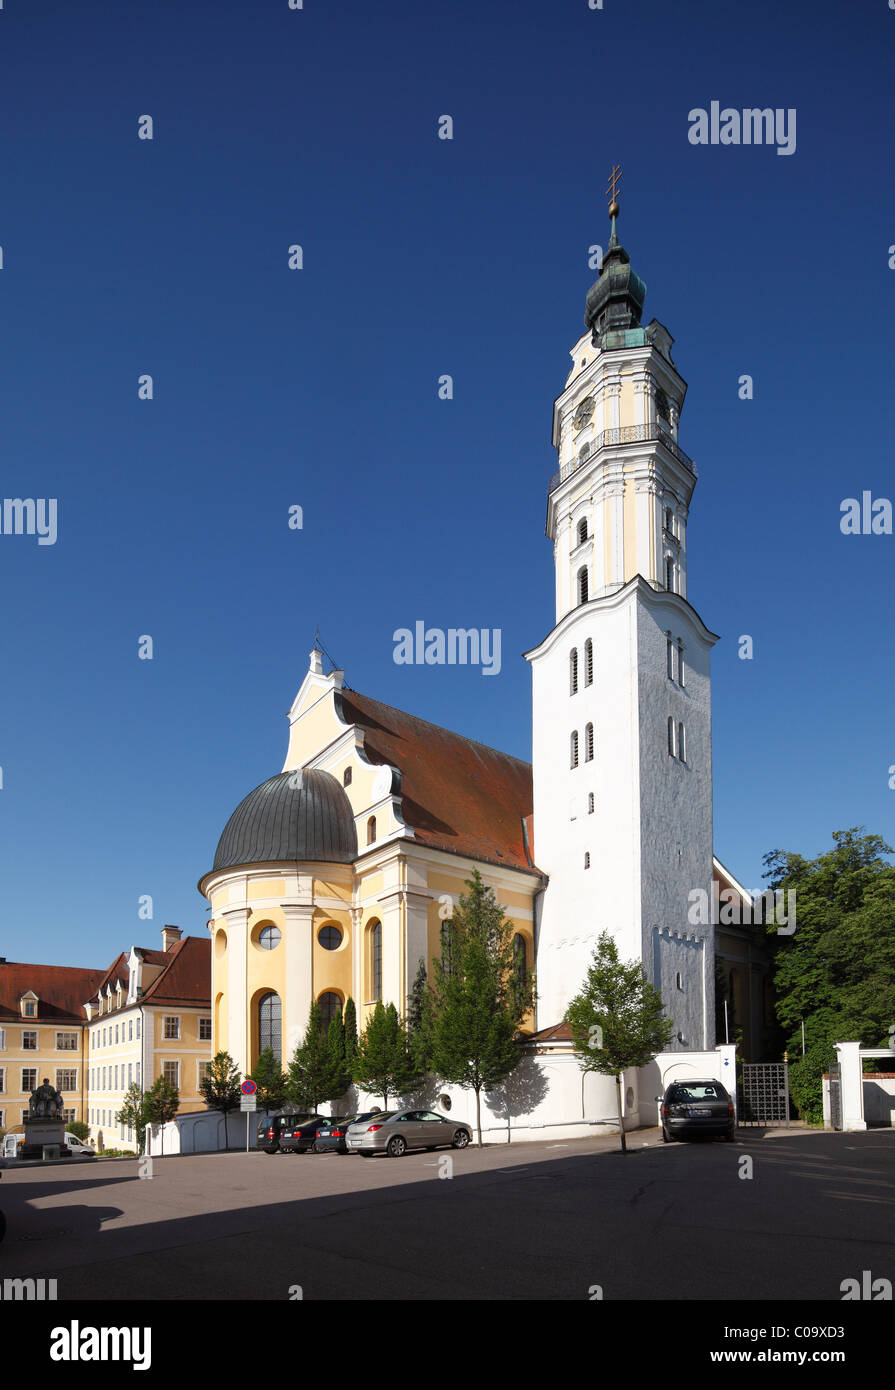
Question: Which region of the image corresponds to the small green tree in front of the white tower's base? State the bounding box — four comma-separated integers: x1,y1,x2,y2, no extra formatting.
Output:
566,931,674,1154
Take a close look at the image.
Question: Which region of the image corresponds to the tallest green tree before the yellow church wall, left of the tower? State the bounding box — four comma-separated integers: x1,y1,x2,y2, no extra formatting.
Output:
427,869,534,1147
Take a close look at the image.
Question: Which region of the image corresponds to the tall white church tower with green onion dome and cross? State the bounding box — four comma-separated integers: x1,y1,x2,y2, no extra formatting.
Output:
527,189,717,1051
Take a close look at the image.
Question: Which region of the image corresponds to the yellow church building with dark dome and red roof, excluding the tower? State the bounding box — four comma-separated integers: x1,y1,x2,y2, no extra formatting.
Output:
199,651,543,1072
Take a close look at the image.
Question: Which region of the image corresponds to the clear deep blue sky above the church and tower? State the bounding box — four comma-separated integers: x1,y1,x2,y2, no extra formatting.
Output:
0,0,895,966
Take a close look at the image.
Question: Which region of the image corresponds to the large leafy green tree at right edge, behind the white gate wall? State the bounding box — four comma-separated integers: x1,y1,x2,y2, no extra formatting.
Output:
764,826,895,1123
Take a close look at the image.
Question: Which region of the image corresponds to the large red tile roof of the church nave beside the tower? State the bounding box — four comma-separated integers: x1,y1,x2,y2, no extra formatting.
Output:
339,689,536,873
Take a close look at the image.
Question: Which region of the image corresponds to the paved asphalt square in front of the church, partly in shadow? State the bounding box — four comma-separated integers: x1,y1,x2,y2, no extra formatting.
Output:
0,1130,895,1301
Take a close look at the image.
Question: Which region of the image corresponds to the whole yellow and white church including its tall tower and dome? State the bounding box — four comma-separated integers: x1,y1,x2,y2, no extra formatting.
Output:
199,190,755,1138
